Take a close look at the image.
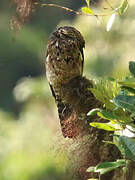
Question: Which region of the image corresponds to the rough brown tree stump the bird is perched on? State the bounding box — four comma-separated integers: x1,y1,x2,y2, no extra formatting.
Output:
57,76,126,180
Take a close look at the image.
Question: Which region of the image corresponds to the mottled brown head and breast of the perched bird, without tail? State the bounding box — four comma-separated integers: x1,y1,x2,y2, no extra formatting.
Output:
46,26,84,86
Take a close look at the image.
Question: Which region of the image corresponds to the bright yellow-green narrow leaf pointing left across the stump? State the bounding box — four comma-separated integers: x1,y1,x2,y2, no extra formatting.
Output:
90,122,117,131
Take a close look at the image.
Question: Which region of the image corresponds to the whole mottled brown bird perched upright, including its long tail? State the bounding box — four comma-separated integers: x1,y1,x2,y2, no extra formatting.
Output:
45,26,85,137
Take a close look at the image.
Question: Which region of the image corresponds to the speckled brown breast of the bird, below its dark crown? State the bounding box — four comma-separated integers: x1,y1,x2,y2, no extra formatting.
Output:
46,40,82,85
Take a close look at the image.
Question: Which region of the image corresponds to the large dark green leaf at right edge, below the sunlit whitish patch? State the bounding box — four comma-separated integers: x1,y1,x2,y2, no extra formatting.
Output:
116,136,135,161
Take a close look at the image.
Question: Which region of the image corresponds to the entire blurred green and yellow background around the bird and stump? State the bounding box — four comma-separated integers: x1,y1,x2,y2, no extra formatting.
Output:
0,0,135,180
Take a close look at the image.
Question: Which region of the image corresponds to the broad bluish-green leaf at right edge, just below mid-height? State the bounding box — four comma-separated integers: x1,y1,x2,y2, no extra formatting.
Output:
114,95,135,114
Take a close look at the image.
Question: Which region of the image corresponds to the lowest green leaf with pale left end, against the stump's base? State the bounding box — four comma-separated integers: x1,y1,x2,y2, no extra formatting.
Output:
95,159,126,175
